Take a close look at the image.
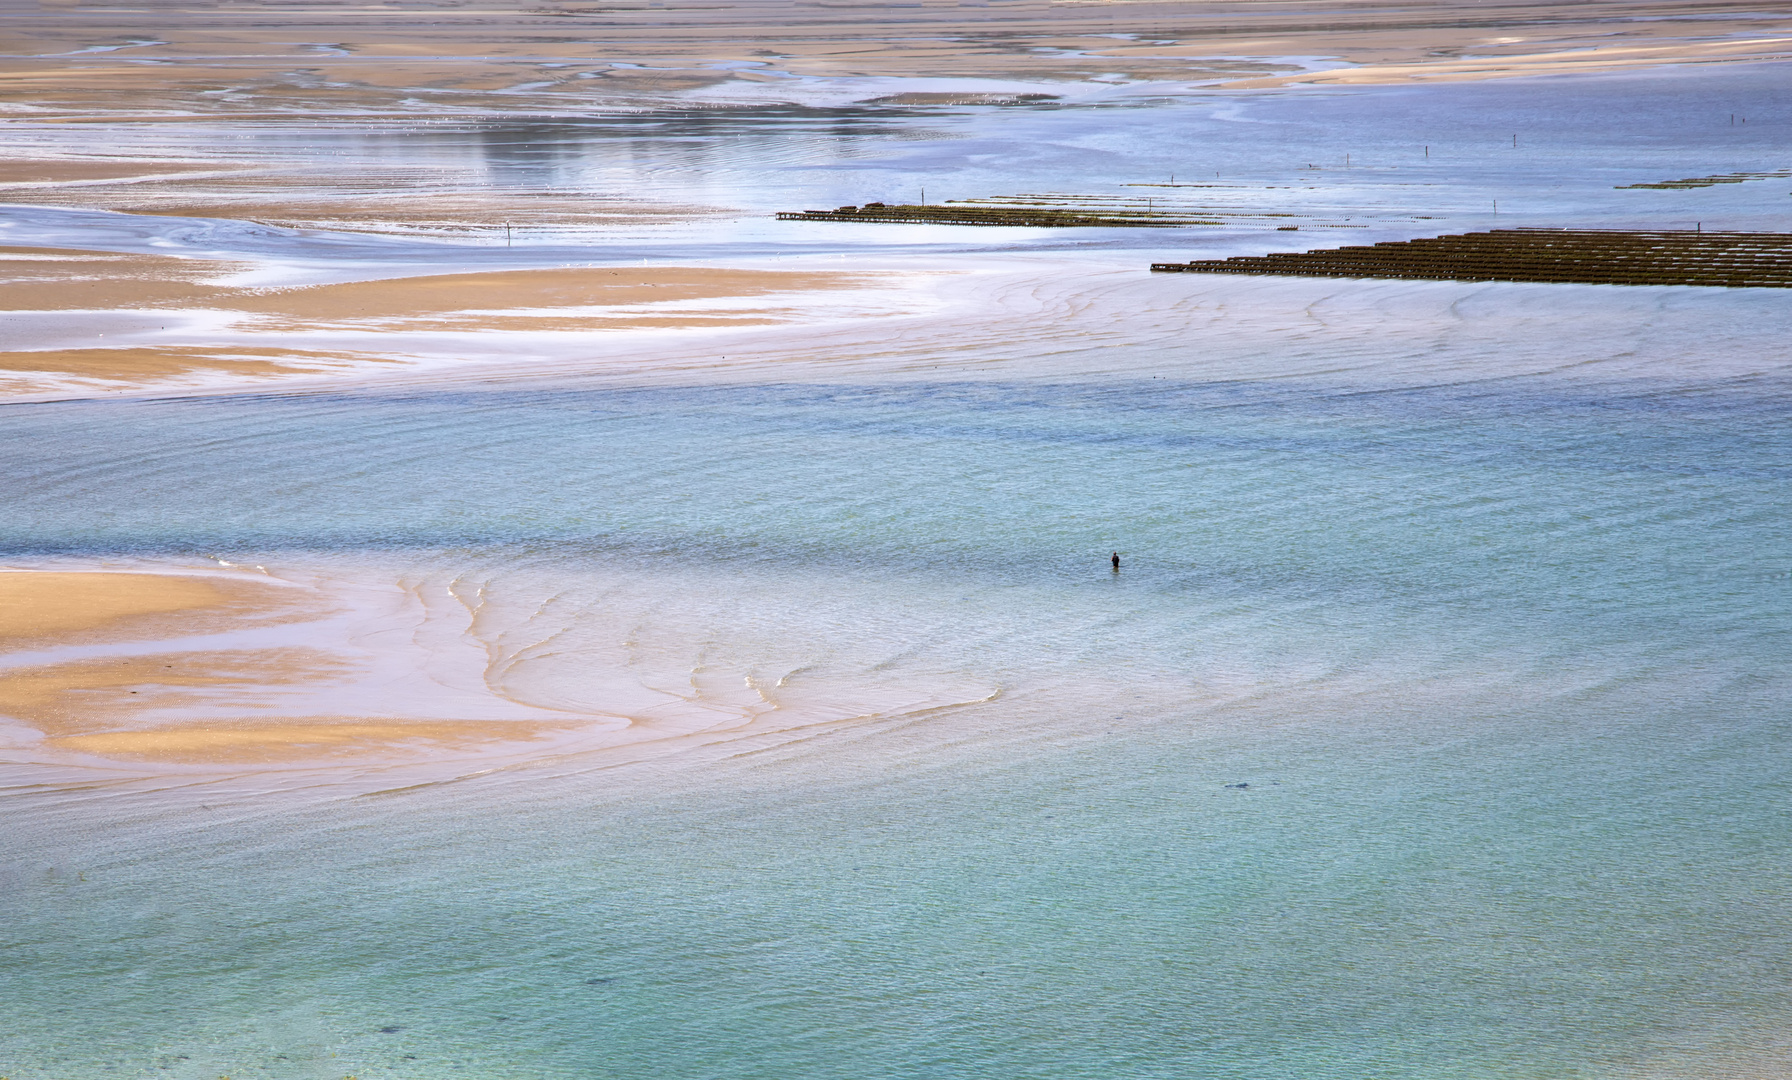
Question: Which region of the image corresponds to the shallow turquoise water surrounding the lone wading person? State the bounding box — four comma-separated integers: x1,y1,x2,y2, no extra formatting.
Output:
0,365,1792,1078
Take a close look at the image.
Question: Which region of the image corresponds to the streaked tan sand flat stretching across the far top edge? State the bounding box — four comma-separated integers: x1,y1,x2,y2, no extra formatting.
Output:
0,0,1788,115
